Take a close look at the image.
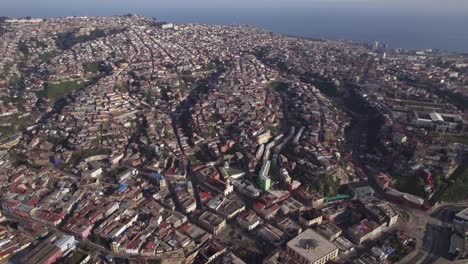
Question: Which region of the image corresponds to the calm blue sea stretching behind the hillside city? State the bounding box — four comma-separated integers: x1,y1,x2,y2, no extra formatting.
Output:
0,0,468,53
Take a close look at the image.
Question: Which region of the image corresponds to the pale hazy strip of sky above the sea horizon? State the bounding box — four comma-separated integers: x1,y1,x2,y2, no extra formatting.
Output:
0,0,468,16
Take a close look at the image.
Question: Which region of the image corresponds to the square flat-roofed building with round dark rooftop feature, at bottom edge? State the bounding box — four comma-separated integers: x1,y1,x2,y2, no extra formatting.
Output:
286,229,338,264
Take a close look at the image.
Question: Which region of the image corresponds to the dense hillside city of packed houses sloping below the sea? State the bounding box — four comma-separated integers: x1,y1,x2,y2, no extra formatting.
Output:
0,15,468,264
